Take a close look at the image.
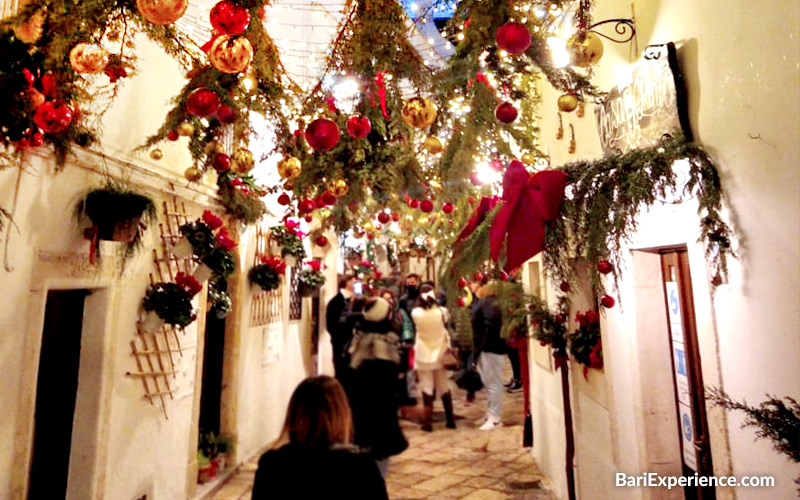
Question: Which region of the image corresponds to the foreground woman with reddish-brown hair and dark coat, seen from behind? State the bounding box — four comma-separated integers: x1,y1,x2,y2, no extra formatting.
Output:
252,375,389,500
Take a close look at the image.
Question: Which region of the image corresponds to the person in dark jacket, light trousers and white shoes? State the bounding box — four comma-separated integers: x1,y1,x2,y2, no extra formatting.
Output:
472,282,508,430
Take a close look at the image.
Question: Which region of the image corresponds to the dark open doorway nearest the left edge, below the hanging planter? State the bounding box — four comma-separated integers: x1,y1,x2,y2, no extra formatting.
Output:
28,290,90,500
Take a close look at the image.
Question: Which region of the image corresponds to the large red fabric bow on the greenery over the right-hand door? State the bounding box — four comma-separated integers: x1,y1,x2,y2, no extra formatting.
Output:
489,160,567,271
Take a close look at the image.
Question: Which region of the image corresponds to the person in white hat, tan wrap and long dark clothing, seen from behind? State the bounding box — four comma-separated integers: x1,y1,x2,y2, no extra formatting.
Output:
347,297,408,477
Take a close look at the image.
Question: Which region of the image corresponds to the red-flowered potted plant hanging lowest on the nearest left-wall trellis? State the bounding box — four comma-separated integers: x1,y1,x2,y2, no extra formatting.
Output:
139,282,198,333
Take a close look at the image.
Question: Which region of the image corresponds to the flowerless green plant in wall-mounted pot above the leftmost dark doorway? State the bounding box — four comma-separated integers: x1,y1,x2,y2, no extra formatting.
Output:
75,181,156,263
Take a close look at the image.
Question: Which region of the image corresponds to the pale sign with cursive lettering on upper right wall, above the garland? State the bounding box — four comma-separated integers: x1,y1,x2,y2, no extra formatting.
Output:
595,42,691,155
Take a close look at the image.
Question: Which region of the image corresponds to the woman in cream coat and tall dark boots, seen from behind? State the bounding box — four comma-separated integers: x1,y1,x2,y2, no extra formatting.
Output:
411,285,456,432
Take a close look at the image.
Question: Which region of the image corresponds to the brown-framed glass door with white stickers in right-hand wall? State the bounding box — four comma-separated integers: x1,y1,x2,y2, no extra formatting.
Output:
659,252,716,500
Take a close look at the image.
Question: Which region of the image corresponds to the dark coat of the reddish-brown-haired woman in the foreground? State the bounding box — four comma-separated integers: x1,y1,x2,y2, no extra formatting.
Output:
253,444,389,500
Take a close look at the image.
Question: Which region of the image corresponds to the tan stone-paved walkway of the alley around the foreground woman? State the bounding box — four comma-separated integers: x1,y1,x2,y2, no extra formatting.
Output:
211,374,555,500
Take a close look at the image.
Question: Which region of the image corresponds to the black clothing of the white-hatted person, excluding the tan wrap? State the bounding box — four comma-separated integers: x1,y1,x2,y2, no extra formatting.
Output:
345,319,408,460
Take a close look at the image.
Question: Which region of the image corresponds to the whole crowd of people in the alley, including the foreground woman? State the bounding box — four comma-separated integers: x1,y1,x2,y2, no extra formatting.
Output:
253,274,521,500
